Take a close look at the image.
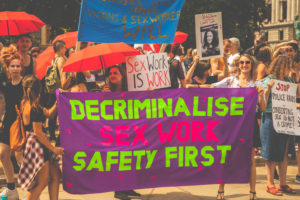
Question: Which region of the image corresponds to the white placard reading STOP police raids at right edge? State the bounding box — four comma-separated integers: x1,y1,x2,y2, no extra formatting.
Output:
271,80,300,135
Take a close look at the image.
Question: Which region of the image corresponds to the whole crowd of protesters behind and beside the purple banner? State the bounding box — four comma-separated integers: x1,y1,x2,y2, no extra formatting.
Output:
0,33,300,200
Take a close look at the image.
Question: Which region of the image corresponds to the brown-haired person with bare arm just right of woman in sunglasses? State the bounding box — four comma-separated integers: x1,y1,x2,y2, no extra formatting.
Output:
256,46,273,81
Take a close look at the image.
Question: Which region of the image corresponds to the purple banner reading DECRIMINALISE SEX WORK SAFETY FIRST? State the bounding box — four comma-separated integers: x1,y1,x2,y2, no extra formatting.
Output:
58,88,257,194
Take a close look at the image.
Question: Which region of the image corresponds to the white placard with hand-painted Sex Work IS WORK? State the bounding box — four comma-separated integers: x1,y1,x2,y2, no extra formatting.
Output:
126,53,171,91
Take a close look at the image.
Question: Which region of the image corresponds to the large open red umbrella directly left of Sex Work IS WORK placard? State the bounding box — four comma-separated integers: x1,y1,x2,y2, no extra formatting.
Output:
63,42,140,72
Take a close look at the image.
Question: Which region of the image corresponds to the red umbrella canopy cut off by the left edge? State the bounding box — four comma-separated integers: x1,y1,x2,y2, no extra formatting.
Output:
0,11,45,36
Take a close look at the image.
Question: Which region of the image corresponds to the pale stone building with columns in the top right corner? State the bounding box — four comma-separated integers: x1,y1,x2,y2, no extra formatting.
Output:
261,0,300,46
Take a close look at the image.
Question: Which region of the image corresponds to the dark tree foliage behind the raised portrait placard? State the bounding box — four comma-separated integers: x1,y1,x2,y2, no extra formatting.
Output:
178,0,268,49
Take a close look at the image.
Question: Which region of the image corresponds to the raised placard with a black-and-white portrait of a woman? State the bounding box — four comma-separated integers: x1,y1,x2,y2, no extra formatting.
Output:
195,12,224,60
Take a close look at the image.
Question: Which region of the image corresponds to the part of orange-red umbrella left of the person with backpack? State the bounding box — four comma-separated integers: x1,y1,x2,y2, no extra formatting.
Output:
35,46,55,79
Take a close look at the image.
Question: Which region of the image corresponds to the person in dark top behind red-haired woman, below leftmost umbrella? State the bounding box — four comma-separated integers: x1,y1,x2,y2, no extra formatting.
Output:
17,34,35,76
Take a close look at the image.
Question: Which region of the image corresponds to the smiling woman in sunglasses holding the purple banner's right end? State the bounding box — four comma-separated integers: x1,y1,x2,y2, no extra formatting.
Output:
213,54,266,200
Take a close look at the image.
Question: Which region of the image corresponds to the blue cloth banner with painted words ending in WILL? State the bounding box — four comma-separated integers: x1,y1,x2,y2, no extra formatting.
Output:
78,0,185,44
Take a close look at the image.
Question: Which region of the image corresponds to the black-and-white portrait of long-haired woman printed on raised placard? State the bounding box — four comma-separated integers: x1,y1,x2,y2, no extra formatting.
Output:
202,30,220,57
